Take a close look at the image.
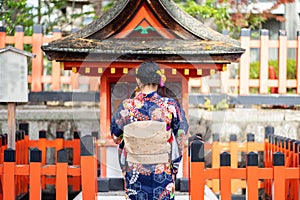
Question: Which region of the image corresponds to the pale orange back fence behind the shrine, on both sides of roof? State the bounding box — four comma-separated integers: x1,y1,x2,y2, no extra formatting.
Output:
0,25,300,95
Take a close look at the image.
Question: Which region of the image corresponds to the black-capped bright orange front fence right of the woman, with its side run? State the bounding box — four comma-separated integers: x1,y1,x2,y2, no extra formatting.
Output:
189,134,300,200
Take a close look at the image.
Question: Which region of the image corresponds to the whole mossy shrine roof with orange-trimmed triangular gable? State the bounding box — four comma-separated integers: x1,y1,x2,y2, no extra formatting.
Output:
42,0,244,63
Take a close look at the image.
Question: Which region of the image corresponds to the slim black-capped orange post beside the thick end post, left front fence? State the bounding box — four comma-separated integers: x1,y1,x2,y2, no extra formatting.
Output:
55,149,68,199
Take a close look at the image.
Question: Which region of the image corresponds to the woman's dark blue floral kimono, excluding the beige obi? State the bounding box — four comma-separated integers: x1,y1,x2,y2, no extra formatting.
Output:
111,92,188,200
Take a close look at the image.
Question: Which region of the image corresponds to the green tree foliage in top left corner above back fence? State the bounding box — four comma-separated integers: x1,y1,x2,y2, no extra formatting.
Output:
0,0,34,35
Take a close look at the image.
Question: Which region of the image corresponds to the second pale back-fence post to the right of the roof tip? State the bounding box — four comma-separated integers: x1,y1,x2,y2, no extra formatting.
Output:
259,29,269,94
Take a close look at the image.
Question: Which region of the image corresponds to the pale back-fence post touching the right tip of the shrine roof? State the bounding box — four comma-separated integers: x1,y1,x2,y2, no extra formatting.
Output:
240,29,250,95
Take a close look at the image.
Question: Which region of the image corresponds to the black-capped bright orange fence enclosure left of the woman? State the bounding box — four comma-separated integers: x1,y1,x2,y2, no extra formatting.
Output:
0,124,98,200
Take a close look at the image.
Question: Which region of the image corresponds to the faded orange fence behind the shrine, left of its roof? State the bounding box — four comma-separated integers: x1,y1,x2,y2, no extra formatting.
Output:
0,25,98,92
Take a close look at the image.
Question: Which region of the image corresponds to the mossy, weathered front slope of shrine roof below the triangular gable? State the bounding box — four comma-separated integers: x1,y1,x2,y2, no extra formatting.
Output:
42,38,244,55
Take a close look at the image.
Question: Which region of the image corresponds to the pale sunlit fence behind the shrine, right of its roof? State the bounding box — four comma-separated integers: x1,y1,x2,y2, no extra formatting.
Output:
186,29,300,95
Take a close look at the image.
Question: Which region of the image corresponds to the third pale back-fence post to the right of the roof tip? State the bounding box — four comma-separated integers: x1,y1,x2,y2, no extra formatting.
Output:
278,30,287,94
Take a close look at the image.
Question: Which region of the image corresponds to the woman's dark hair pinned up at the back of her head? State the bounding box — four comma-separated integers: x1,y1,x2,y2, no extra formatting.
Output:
136,62,161,85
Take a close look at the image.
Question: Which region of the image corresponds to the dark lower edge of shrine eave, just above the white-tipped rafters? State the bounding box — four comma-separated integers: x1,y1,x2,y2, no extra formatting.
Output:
41,51,243,64
